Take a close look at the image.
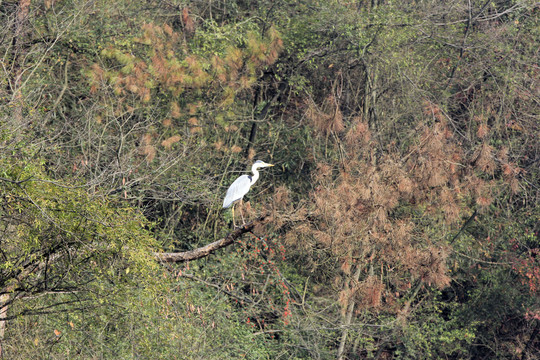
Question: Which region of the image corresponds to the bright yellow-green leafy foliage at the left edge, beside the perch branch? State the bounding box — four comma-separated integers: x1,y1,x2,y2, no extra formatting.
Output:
0,132,157,316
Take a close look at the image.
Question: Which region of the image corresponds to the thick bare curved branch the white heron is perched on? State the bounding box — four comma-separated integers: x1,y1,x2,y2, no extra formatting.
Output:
154,215,268,263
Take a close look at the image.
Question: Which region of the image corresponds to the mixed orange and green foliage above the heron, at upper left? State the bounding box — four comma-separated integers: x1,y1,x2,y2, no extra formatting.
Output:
87,22,283,142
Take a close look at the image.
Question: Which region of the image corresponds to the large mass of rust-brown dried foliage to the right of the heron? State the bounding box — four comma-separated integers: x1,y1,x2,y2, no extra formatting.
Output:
276,100,510,312
